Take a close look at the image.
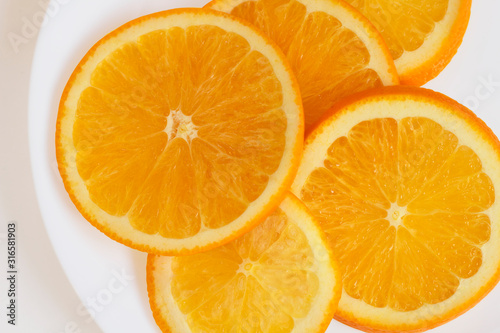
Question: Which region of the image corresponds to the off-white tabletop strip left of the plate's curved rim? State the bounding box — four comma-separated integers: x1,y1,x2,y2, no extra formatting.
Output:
0,0,101,333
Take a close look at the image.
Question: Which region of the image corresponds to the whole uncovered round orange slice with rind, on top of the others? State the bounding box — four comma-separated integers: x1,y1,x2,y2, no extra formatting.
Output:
56,9,303,254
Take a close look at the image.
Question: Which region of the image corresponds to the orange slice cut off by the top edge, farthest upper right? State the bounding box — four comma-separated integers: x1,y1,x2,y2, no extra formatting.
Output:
346,0,472,86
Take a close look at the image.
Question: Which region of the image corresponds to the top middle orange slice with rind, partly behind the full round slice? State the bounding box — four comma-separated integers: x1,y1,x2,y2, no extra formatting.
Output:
207,0,398,130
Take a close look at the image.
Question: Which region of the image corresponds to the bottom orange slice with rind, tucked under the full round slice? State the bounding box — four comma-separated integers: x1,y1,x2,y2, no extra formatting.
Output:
148,195,341,332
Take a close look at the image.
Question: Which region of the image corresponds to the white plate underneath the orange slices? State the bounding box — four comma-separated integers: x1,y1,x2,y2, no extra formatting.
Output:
29,0,500,333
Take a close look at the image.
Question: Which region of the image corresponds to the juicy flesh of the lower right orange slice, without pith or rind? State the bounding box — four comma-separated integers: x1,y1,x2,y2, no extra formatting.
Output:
301,117,495,311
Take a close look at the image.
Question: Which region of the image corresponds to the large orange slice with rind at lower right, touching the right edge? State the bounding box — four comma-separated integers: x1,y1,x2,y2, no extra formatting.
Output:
292,86,500,332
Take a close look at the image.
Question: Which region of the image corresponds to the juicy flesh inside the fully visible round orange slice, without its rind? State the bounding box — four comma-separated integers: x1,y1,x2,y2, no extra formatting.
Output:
73,25,286,231
